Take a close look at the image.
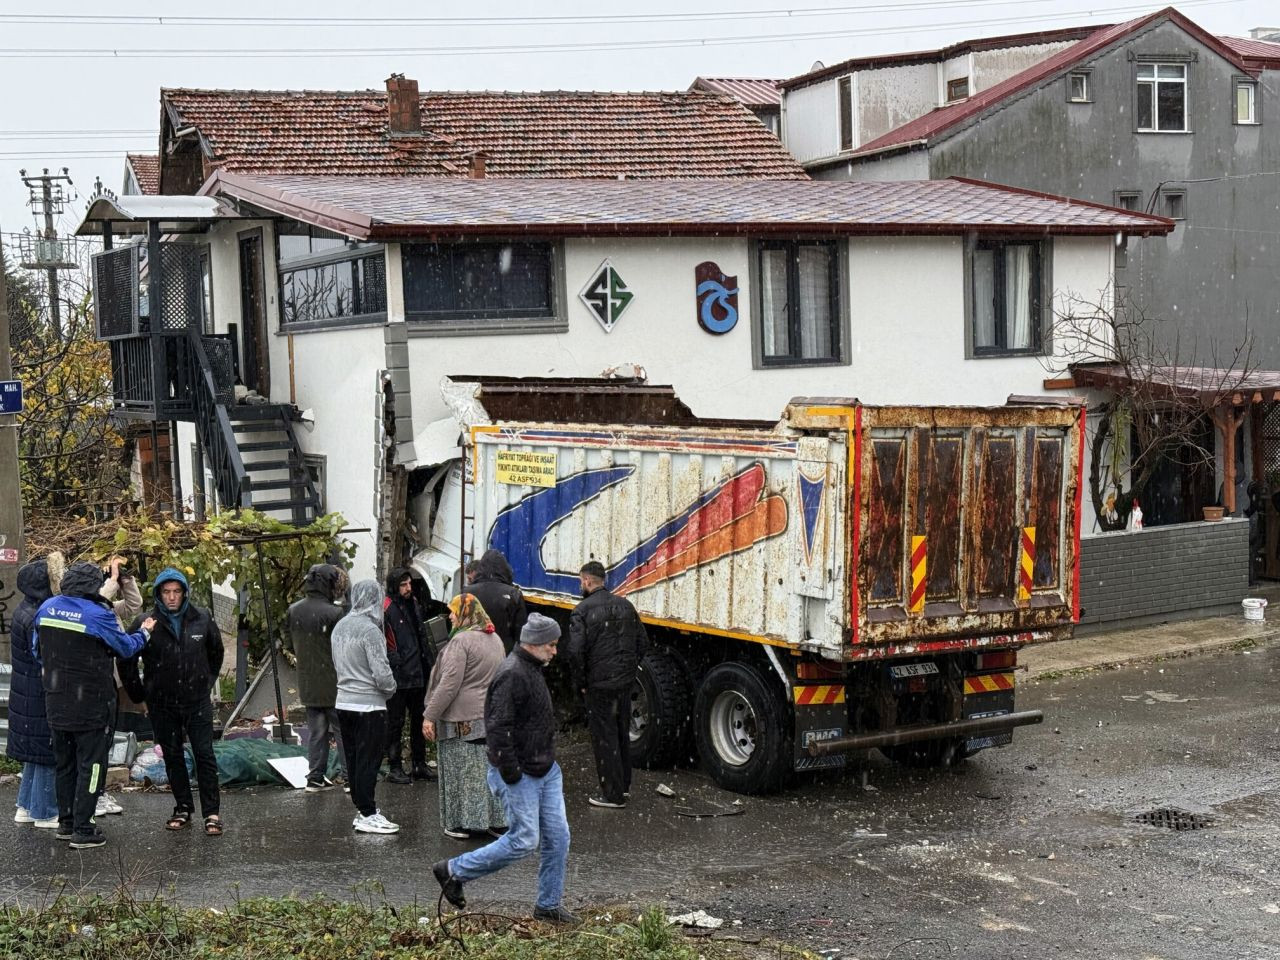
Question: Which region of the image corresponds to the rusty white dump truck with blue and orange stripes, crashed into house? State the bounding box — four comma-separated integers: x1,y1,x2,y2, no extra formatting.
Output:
424,378,1084,794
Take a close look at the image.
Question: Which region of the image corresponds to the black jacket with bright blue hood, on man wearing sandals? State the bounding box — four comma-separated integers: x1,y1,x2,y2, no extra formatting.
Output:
120,567,223,708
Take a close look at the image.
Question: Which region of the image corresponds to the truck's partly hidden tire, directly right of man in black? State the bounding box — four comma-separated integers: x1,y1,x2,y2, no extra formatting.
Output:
630,650,694,769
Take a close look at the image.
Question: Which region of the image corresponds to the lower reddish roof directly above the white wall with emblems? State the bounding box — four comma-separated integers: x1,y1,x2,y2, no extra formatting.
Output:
206,173,1174,239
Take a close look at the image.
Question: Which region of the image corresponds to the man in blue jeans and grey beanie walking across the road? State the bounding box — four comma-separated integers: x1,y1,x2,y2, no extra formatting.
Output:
431,613,577,923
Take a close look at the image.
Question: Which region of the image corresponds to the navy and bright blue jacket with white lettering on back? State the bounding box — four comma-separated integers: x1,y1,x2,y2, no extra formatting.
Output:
32,563,147,731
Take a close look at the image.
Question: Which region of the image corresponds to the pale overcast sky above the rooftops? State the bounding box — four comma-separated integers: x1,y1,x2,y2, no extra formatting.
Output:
0,0,1280,240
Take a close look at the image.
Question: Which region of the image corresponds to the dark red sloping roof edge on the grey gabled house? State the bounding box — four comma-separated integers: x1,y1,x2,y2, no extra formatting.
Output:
850,6,1248,156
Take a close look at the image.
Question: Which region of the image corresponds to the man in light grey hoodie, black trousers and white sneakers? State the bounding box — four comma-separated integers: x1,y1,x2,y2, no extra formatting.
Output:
330,580,399,833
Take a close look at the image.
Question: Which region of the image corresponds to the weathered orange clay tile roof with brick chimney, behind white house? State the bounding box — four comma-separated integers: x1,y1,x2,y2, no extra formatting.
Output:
161,90,806,179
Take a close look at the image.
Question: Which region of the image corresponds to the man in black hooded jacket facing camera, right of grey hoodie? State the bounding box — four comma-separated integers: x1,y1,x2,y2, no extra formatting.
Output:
383,567,435,783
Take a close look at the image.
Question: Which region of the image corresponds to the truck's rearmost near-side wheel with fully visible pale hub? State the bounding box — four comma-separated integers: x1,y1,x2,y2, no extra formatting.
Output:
695,663,791,794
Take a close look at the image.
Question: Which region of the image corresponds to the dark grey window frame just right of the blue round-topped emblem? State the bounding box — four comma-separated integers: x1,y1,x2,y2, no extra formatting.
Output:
750,236,850,370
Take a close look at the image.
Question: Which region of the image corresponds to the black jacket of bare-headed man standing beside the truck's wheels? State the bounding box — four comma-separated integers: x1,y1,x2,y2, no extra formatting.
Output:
568,586,648,690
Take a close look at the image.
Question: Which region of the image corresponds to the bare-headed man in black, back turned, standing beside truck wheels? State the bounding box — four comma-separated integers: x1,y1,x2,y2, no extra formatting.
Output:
568,561,648,809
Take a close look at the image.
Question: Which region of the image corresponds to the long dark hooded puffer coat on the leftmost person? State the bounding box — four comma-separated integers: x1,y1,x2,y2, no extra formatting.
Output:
5,561,54,767
